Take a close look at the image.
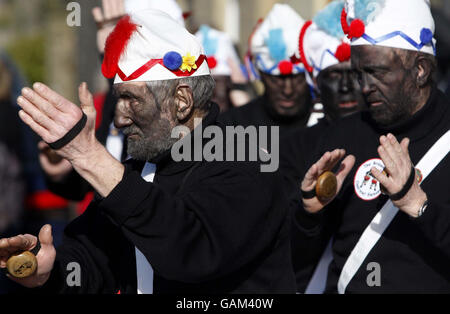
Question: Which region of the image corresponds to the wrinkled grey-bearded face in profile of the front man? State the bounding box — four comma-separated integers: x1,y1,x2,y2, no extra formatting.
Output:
114,82,176,162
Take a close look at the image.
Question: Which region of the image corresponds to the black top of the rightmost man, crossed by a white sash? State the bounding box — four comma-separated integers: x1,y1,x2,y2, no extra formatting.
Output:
296,89,450,293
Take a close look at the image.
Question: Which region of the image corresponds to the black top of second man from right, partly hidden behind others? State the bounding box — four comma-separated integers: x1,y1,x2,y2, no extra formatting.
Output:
280,119,331,293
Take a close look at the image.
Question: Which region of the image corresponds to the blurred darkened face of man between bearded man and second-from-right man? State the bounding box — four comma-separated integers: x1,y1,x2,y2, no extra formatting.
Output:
261,73,311,118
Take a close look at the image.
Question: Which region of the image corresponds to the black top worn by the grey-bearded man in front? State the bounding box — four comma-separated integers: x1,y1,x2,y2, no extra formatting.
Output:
40,105,295,294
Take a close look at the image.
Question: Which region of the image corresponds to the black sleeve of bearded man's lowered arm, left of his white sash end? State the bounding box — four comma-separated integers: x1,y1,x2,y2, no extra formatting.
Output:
36,202,130,294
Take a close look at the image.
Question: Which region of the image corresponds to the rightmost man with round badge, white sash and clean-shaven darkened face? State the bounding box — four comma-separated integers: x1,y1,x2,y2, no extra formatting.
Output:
296,0,450,293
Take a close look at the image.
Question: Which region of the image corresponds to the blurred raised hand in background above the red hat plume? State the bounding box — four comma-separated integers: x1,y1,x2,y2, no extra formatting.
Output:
92,0,126,53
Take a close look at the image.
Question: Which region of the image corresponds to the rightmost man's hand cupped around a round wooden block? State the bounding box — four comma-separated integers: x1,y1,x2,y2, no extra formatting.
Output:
301,149,355,213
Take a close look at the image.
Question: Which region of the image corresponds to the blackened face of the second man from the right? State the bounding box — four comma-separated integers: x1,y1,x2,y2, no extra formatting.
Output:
317,61,364,120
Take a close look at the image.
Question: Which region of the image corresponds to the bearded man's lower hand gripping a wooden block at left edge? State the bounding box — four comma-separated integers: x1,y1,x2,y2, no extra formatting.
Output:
0,225,56,288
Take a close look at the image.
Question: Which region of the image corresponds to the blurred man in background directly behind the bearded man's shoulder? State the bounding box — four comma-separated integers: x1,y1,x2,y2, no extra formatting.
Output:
221,4,312,140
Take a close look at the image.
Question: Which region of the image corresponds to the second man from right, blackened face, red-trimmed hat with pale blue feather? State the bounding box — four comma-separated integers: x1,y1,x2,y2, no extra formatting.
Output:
280,0,364,293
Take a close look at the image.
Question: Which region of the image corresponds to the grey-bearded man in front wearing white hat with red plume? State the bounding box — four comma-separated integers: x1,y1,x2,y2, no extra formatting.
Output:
0,11,295,294
